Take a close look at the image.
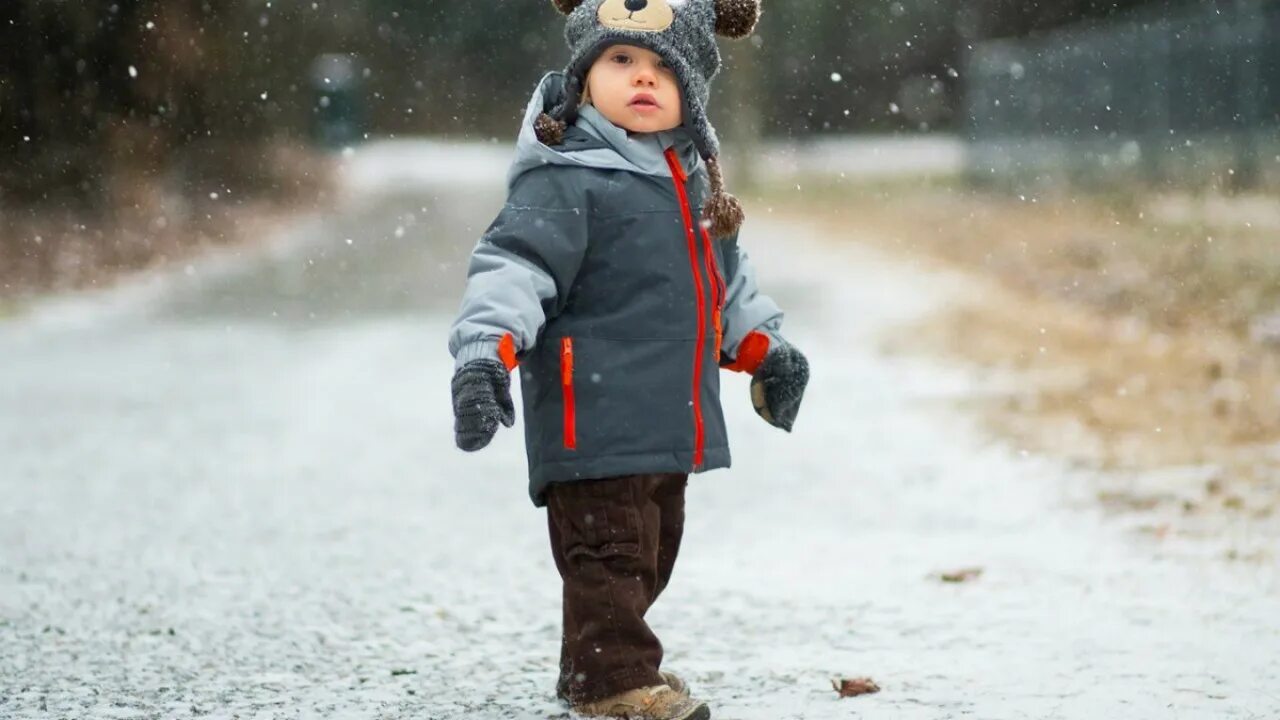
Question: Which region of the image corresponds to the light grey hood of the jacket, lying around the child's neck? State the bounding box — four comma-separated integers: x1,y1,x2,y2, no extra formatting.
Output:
507,72,703,190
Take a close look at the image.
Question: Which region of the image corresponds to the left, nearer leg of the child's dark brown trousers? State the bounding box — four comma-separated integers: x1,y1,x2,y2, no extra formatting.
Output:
547,475,664,702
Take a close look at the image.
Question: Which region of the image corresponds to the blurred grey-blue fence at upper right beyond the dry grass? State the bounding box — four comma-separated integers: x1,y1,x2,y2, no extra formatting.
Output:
965,1,1280,190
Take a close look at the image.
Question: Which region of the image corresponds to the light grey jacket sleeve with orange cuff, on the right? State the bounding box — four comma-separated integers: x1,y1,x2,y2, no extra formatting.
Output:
721,234,783,373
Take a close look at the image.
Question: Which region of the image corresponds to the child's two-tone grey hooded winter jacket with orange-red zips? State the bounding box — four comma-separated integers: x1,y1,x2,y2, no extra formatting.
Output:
449,73,782,506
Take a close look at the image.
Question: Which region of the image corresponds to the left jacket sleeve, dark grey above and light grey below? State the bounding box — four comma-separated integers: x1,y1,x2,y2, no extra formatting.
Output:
449,165,589,370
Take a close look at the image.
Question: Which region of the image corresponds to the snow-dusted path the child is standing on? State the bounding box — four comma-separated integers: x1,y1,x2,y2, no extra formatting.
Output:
0,145,1280,720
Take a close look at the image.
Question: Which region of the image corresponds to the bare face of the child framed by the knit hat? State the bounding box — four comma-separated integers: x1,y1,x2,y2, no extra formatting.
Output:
586,45,681,132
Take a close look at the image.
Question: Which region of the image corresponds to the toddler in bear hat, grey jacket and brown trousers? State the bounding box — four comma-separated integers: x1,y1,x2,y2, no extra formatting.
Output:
449,0,809,720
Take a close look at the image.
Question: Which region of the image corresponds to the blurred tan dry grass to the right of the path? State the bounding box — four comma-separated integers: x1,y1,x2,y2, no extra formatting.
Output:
764,179,1280,530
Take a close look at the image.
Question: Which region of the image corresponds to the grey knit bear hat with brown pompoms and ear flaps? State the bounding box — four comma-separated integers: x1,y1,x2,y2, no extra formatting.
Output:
534,0,760,237
